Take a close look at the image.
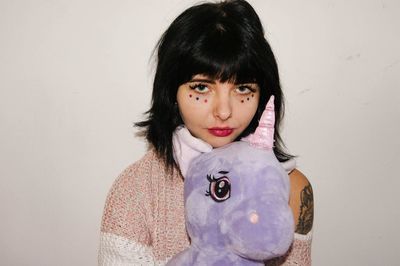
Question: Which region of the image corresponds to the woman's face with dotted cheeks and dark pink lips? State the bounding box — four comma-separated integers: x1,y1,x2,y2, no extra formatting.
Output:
177,74,260,148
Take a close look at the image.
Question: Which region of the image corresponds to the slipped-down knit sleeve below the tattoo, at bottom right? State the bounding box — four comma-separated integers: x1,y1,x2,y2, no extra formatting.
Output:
265,231,312,266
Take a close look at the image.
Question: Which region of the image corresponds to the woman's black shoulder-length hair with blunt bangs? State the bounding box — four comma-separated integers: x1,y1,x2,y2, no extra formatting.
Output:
135,0,293,168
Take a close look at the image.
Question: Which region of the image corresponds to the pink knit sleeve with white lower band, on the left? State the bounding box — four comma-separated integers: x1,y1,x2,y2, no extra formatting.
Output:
98,165,154,266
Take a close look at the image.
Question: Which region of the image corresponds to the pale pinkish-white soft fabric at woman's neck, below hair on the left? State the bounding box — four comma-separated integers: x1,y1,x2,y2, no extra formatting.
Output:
172,126,212,177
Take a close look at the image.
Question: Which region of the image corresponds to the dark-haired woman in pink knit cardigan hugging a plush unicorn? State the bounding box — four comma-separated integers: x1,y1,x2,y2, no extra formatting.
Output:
99,0,313,265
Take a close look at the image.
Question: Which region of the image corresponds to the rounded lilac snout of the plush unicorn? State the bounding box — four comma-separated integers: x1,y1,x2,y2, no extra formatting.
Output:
220,189,294,261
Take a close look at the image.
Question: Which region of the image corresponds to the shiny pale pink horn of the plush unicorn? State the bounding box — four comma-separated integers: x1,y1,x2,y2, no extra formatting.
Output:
242,95,275,150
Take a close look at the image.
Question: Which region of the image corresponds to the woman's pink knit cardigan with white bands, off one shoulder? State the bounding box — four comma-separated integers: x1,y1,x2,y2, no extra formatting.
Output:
99,150,311,265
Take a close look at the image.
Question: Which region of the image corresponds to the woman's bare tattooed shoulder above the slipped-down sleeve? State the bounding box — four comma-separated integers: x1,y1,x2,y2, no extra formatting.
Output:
289,169,314,235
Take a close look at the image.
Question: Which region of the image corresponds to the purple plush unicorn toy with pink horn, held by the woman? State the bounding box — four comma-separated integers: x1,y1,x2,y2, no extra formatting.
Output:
167,96,294,266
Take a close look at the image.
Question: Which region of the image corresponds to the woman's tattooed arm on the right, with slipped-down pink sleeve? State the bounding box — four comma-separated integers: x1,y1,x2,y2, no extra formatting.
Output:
266,169,314,266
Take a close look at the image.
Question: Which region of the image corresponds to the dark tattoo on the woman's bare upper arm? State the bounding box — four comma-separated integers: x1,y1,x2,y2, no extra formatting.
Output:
296,184,314,235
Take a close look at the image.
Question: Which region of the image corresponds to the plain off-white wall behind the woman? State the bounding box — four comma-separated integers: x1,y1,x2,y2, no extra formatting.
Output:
0,0,400,265
